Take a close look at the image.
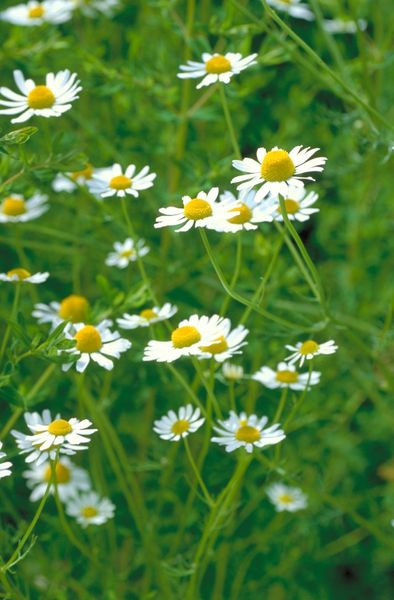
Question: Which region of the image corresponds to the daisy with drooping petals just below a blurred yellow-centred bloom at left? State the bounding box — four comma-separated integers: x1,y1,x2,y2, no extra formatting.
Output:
63,320,131,373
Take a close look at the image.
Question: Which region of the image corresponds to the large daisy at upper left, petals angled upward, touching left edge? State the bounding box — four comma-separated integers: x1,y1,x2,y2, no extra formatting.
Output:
0,69,82,123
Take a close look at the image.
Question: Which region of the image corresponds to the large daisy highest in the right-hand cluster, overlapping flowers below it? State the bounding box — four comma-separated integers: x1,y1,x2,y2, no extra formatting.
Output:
231,146,327,202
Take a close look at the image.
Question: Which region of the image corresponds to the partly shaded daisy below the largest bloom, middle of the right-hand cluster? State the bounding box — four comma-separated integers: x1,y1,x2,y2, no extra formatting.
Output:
212,191,275,233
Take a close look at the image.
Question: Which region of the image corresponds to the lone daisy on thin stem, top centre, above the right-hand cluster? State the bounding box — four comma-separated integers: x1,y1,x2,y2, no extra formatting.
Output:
178,52,257,90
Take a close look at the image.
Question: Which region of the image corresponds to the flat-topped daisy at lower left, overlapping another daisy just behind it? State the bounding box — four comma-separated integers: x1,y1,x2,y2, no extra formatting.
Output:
28,417,97,452
